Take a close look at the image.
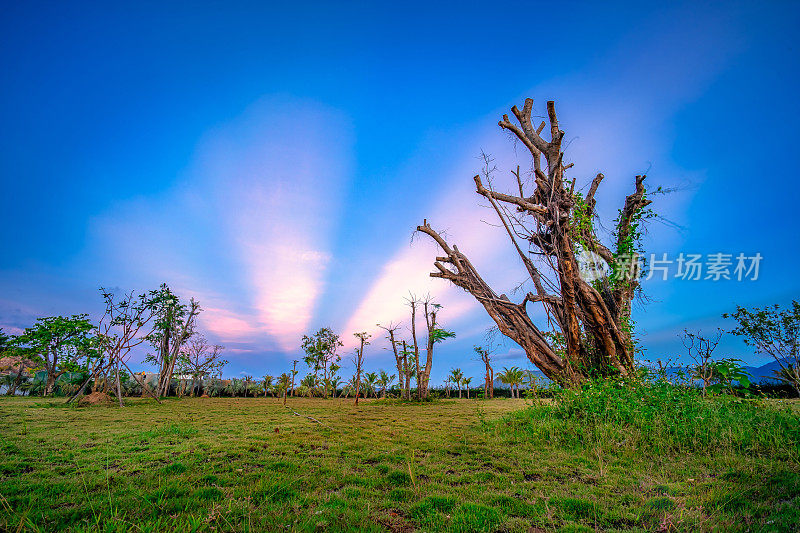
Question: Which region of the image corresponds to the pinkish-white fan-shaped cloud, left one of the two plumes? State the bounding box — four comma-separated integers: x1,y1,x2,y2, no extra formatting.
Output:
84,98,352,351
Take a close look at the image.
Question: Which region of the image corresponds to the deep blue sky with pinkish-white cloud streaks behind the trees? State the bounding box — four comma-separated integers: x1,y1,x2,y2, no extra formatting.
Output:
0,2,800,380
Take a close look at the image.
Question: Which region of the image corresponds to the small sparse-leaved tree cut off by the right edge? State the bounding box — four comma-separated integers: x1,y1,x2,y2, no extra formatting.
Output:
722,300,800,394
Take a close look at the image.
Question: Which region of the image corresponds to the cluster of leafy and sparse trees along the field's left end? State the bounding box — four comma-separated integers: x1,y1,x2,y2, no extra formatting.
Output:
0,284,227,405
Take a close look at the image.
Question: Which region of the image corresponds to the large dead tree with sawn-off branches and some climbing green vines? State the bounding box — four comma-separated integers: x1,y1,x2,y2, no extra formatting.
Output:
417,98,650,384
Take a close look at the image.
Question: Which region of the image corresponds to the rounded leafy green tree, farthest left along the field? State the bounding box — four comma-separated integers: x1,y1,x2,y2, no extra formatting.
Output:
19,314,94,396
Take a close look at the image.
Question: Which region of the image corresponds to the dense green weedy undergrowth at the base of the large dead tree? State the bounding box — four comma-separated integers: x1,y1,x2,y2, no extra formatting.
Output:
505,381,800,458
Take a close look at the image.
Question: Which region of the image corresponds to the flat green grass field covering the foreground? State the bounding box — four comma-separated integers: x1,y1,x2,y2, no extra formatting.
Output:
0,398,800,532
